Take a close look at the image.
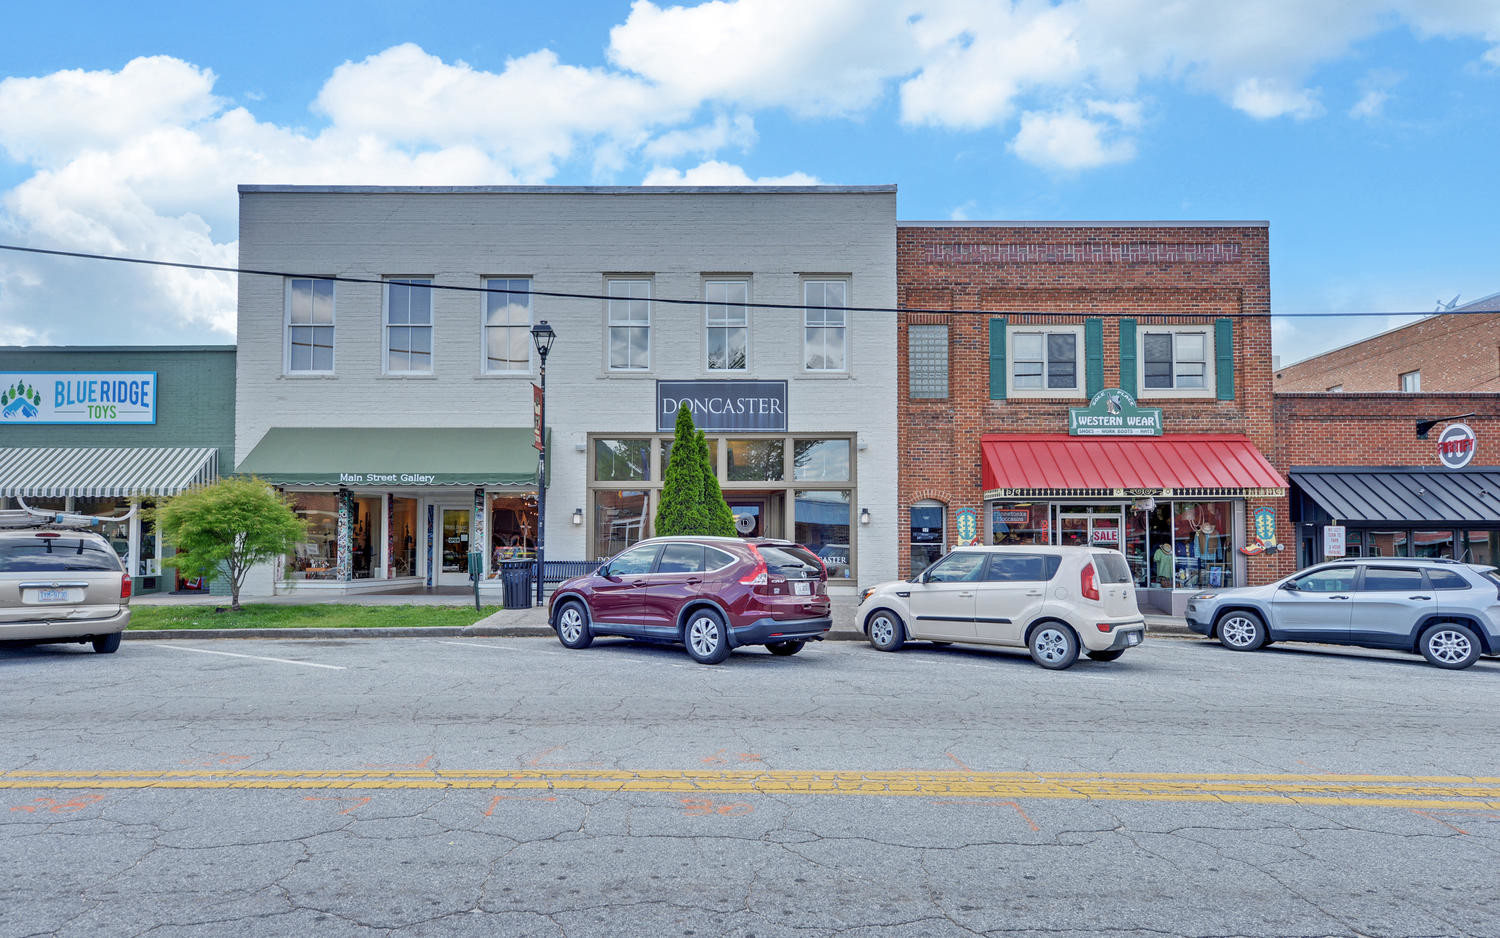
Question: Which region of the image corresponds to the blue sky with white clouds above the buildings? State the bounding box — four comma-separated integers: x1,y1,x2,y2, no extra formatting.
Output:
0,0,1500,363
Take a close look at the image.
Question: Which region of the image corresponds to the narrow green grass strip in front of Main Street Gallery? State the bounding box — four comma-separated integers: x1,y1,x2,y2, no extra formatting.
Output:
131,600,500,629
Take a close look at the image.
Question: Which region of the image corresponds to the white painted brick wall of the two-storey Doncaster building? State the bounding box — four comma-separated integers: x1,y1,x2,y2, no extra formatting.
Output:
236,186,897,584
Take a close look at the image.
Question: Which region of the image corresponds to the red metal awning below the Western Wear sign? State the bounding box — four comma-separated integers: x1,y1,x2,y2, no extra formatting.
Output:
981,434,1287,498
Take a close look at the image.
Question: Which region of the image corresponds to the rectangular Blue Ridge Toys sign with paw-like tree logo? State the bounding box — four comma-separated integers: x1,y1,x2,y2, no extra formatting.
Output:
0,371,156,426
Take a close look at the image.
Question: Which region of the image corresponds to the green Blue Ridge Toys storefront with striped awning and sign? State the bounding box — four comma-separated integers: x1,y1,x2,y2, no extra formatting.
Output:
0,345,236,591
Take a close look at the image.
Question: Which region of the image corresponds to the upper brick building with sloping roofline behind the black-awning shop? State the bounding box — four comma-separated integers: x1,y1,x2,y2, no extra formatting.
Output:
1275,293,1500,393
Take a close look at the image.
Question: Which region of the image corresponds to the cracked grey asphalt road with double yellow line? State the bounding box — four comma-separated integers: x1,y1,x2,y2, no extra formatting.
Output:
0,638,1500,938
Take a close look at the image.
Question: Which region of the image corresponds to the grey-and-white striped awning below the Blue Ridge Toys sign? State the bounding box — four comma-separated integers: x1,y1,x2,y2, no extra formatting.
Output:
0,446,219,498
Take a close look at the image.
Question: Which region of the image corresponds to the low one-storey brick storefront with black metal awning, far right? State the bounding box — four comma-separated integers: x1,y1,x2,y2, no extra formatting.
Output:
1274,392,1500,566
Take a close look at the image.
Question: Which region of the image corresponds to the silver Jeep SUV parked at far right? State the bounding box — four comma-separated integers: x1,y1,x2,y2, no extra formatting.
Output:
1187,557,1500,669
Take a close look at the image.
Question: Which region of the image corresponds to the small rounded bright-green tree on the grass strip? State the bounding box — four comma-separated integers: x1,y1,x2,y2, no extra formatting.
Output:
155,479,308,609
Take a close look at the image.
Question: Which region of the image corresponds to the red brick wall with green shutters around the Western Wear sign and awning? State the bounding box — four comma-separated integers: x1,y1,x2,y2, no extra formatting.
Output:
897,222,1293,600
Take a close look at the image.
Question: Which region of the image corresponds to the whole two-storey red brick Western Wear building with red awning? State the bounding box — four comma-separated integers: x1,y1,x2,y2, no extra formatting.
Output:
897,222,1293,608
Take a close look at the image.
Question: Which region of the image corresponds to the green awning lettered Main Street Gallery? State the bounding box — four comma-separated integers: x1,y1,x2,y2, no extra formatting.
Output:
234,426,552,488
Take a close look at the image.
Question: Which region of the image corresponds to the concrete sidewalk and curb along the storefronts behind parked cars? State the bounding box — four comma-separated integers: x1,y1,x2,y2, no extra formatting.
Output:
125,593,1193,641
